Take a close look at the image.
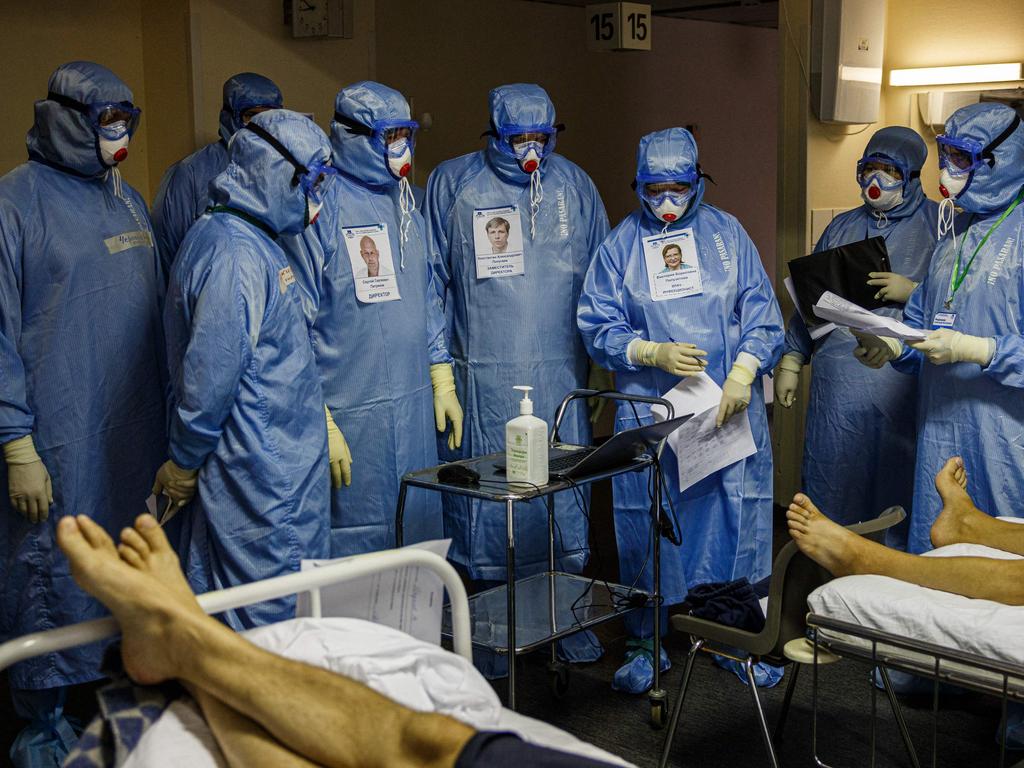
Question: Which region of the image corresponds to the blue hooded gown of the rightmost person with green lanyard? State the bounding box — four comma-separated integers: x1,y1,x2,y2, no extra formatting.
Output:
893,103,1024,553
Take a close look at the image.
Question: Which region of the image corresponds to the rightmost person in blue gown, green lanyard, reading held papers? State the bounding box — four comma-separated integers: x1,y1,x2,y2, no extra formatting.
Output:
856,103,1024,553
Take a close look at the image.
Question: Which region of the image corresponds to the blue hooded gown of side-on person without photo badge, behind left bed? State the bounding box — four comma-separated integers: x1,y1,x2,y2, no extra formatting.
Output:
164,110,331,628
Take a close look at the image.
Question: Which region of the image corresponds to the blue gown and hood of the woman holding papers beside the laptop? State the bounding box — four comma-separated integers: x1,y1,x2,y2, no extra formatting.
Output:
578,128,783,614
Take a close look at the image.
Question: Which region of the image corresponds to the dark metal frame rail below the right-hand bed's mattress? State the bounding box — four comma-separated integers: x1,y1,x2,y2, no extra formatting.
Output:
807,613,1024,768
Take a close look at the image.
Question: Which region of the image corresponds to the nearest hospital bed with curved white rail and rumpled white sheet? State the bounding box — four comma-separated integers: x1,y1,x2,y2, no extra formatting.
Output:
0,548,631,768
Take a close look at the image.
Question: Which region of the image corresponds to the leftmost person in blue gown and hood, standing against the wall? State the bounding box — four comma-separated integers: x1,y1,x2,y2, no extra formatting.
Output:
0,61,166,766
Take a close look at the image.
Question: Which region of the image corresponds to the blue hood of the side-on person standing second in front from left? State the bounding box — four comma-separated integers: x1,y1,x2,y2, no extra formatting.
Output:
210,110,331,234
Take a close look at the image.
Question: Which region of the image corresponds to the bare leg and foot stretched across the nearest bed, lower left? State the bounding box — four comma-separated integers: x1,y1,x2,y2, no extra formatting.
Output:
57,515,473,768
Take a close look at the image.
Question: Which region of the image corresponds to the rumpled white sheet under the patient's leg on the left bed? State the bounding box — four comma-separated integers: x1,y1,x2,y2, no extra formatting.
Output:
119,618,631,768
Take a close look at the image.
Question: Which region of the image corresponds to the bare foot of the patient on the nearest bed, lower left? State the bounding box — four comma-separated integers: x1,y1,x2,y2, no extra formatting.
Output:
57,515,207,684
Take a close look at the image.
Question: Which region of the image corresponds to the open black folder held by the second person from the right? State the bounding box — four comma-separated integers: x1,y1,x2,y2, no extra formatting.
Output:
790,237,899,326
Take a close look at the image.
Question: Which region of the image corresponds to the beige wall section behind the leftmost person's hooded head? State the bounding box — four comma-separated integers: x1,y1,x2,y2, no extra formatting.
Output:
0,0,153,195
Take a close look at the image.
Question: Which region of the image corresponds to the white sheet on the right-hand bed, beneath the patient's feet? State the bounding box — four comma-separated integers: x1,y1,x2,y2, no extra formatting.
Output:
807,544,1024,679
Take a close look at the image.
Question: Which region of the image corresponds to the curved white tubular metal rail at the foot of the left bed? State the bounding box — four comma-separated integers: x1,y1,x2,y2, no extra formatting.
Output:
0,548,473,670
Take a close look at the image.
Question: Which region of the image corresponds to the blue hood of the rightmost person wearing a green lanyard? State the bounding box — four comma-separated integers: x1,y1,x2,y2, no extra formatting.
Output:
944,102,1024,214
